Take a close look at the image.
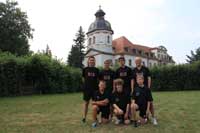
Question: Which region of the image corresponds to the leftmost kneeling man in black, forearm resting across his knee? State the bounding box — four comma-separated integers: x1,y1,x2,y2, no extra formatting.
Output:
92,80,110,127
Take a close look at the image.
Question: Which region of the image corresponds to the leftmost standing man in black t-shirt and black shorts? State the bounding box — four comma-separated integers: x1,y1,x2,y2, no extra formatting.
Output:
82,56,99,122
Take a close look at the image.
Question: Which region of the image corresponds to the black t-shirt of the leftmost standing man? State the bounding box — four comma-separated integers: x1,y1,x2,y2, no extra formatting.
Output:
82,67,99,90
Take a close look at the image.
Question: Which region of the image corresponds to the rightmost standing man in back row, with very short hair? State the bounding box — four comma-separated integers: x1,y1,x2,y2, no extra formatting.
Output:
133,57,158,125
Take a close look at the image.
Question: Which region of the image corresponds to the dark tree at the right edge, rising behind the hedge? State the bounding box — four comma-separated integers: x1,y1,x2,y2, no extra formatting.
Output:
186,47,200,64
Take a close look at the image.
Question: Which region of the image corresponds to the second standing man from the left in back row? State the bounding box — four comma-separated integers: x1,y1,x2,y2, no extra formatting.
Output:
99,60,115,95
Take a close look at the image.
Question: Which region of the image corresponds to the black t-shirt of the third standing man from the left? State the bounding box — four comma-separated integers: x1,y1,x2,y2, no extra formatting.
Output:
116,66,133,89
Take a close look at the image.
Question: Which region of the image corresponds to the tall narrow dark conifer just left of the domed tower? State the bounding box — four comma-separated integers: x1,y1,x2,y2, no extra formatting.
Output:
67,26,85,68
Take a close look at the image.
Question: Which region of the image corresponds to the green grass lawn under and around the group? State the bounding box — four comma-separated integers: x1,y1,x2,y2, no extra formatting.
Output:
0,91,200,133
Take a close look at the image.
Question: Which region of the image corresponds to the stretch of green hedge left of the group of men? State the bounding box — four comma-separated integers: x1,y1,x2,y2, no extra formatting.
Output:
0,53,82,96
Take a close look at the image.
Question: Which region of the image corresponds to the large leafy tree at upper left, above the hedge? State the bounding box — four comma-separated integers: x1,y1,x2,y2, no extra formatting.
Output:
0,0,33,55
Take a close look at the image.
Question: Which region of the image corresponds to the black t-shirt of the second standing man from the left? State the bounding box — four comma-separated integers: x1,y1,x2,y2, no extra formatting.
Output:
99,69,115,92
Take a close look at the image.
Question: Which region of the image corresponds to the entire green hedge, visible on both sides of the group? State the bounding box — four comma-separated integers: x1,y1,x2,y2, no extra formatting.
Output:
0,53,200,96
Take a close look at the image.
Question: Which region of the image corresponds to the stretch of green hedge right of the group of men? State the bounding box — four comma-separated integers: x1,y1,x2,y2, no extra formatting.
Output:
151,62,200,91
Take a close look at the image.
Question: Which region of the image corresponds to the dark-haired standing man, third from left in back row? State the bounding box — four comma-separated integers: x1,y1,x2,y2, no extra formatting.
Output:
116,56,133,95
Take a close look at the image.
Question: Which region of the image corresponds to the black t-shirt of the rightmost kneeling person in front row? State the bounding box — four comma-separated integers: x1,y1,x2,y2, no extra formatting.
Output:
132,86,150,106
